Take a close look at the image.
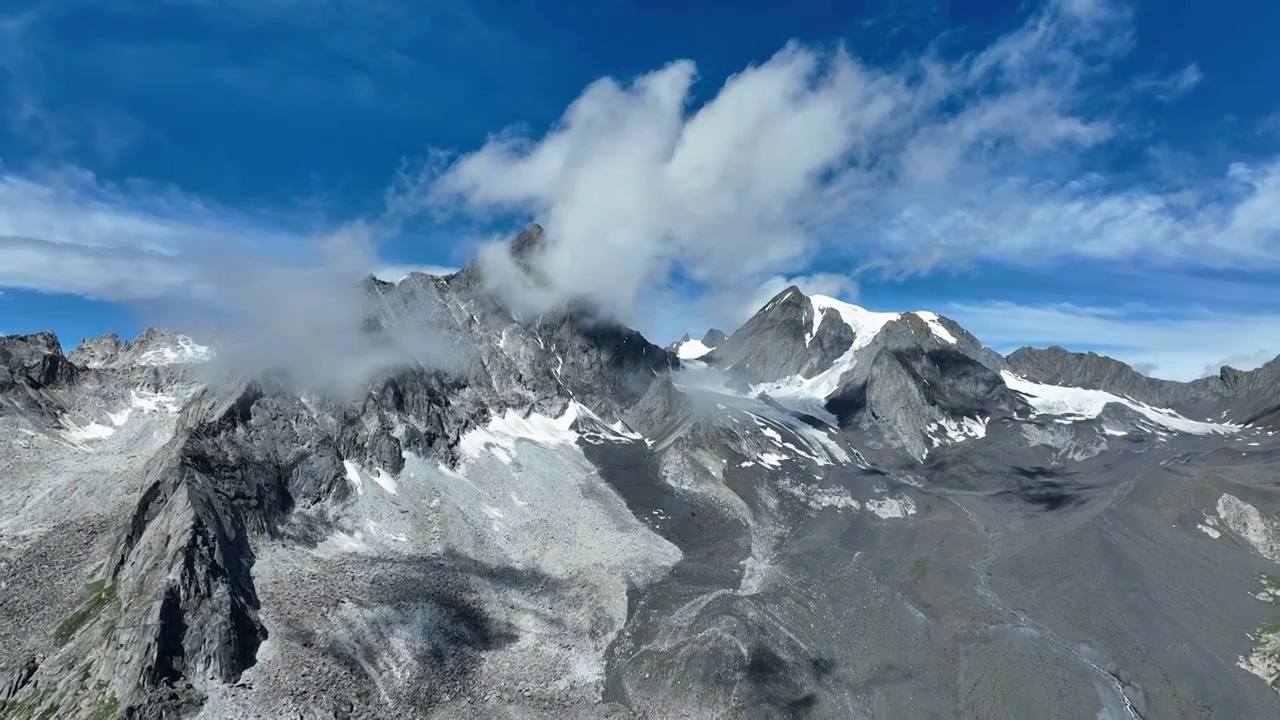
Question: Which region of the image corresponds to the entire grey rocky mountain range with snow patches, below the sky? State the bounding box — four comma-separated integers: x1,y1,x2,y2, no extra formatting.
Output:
0,228,1280,719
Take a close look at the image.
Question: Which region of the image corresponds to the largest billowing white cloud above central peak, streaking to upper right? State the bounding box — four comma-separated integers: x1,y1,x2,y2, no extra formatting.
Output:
426,0,1280,320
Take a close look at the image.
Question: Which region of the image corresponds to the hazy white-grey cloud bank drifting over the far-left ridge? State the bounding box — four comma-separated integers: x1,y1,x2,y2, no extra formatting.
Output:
0,170,458,393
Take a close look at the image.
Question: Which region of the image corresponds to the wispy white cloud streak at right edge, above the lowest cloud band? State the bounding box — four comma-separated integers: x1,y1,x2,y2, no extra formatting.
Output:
865,160,1280,270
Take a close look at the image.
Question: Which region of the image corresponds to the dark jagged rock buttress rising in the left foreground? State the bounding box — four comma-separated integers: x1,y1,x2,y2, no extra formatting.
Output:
108,386,349,706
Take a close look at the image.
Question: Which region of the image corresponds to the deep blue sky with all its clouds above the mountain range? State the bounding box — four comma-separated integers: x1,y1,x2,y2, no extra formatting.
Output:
0,0,1280,378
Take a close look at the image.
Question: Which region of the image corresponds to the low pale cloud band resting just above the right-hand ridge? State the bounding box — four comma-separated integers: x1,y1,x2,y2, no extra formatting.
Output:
941,302,1280,380
